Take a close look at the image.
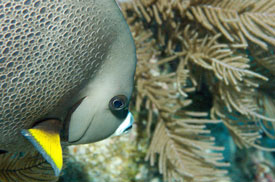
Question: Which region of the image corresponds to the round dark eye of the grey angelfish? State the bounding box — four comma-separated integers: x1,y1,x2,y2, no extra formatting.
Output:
109,95,128,119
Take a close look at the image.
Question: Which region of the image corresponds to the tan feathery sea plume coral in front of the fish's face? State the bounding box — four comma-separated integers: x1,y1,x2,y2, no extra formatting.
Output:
121,0,275,181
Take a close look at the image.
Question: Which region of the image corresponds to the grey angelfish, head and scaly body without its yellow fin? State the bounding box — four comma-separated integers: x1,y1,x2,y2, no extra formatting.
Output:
0,0,136,176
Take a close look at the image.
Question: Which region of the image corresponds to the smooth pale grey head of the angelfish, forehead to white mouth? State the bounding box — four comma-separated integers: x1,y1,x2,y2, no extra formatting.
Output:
66,0,136,144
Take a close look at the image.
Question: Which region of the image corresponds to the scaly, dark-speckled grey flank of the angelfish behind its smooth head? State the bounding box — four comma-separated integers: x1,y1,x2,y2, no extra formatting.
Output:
0,0,116,151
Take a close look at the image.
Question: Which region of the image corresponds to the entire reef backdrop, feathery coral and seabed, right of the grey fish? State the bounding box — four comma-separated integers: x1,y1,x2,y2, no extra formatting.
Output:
59,0,275,182
